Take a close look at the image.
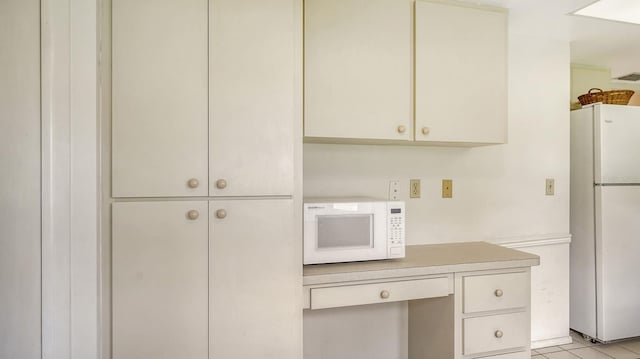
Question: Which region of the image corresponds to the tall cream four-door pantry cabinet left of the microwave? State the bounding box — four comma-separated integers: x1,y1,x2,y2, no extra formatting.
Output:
111,0,302,359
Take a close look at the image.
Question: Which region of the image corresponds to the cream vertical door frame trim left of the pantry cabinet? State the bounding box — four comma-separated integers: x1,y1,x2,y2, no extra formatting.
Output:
40,0,101,359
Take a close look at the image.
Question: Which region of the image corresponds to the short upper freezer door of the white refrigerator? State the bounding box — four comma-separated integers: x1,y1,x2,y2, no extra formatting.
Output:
594,105,640,184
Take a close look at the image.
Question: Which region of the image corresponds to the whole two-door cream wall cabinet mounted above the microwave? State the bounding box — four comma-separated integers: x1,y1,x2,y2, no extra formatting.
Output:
304,0,507,146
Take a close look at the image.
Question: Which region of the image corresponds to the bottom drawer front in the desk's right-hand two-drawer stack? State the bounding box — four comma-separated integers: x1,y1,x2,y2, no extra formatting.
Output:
463,312,530,355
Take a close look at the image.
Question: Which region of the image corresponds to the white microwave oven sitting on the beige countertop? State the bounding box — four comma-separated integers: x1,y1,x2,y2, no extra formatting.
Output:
303,198,405,264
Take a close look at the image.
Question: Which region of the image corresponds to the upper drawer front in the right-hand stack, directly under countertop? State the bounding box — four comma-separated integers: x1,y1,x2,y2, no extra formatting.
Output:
463,272,531,313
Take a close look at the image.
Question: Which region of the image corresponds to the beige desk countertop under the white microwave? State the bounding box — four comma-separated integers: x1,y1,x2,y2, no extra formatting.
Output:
303,242,540,285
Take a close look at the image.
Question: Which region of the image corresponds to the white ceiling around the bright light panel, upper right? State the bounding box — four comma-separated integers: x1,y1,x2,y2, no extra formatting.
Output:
467,0,640,77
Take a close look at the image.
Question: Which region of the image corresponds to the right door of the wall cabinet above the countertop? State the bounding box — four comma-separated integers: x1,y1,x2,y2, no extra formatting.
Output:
415,1,507,143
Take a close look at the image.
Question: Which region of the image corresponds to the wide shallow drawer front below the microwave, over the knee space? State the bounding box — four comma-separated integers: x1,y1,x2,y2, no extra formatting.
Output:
311,277,453,309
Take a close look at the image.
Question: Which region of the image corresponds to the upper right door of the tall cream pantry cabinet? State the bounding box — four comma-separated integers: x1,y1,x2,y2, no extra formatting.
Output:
209,0,296,196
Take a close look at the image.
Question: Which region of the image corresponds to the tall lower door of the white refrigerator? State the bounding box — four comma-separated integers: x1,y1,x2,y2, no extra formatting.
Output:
596,186,640,341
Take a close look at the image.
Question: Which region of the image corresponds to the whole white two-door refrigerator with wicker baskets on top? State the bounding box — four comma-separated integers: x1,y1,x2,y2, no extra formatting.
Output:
570,104,640,342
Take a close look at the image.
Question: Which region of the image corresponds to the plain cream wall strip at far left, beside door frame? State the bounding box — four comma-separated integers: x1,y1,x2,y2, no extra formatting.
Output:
0,0,41,359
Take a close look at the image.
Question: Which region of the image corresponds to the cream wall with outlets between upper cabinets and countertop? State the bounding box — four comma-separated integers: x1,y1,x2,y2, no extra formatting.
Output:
304,8,570,358
